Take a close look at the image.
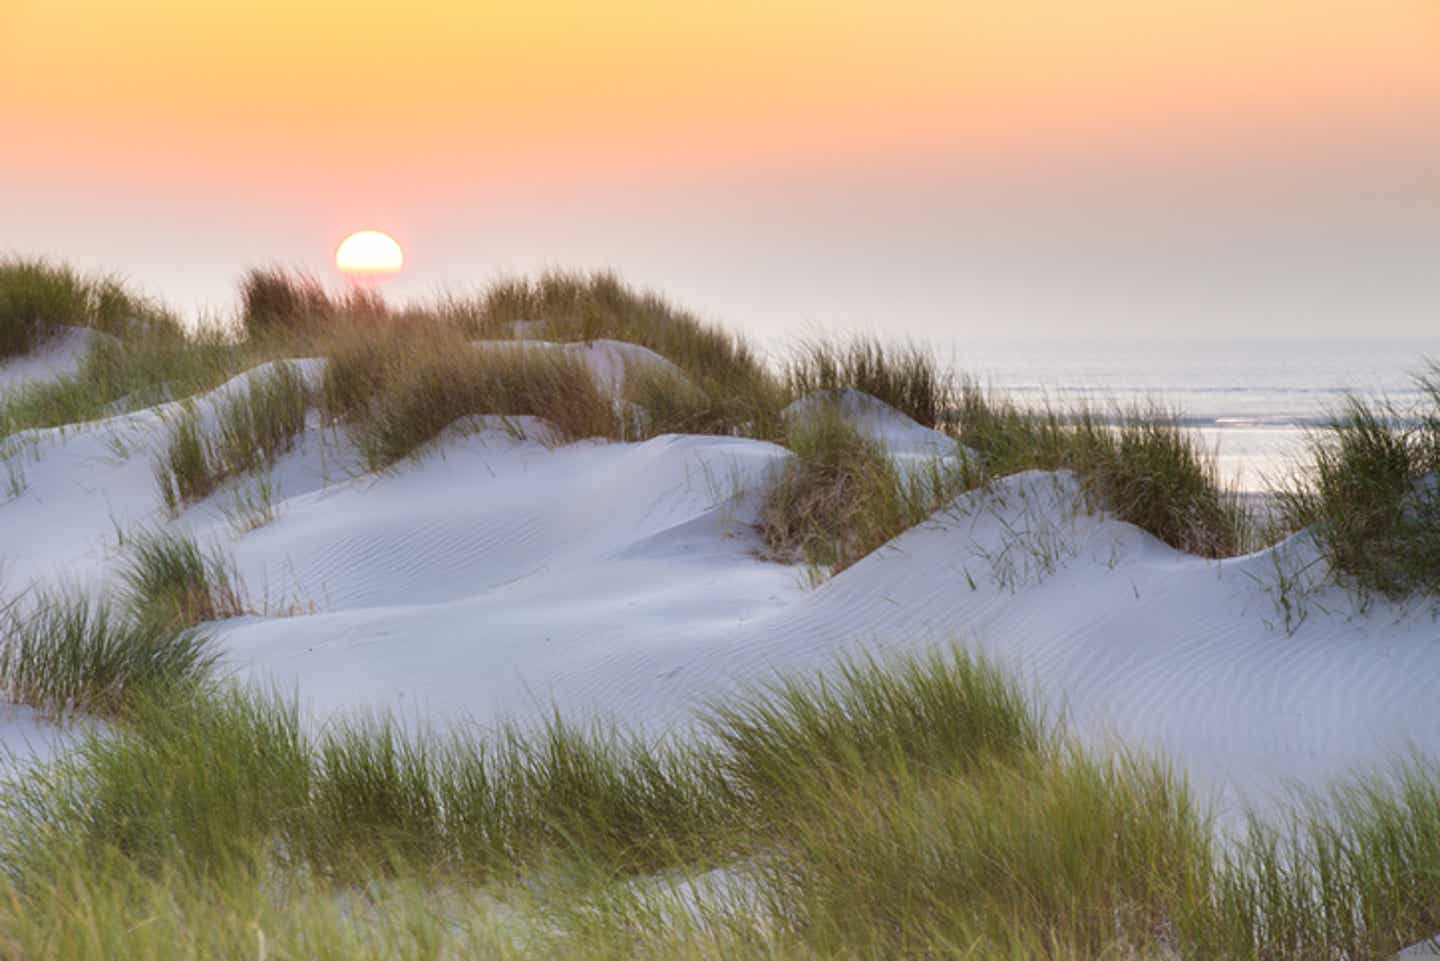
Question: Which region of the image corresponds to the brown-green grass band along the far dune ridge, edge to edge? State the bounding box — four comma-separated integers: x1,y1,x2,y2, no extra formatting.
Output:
0,258,1440,582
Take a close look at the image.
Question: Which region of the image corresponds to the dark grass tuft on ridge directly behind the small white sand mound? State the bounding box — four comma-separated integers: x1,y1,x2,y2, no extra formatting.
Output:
785,337,956,428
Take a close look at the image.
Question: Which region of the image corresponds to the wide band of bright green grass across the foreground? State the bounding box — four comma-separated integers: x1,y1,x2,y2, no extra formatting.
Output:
0,642,1440,961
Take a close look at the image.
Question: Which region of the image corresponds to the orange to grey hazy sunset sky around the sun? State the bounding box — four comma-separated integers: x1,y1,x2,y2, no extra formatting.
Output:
0,0,1440,340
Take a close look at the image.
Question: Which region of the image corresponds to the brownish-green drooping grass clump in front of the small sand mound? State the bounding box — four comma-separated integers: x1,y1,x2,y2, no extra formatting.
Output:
760,403,960,573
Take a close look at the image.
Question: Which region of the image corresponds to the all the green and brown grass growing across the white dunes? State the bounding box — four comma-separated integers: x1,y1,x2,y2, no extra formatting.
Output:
0,261,1440,961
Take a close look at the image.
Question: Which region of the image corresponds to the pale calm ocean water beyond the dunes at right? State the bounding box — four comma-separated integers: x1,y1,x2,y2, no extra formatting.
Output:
936,338,1440,491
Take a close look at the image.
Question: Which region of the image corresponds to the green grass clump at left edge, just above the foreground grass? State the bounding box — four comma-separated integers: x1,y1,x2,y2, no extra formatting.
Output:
0,591,215,718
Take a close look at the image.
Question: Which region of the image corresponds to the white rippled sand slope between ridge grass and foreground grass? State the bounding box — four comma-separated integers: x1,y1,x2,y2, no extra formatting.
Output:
0,344,1440,818
